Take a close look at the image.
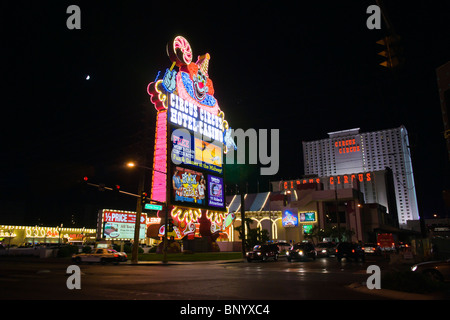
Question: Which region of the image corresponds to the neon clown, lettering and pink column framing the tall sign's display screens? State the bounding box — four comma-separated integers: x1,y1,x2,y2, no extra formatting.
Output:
147,36,234,238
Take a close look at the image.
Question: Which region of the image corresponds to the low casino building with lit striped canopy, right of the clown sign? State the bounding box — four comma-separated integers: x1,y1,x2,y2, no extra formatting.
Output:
227,180,399,243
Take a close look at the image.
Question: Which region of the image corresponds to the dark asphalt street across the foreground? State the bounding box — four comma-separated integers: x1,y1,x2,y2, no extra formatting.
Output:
0,257,387,300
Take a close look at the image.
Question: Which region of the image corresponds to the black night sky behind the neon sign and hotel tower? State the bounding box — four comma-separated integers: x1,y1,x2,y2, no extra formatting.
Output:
0,0,450,227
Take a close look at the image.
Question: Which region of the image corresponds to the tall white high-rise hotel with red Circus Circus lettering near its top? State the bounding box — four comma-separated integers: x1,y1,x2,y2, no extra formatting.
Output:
303,126,419,228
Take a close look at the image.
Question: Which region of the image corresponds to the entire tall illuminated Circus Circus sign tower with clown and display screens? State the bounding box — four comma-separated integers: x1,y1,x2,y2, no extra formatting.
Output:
147,36,234,245
